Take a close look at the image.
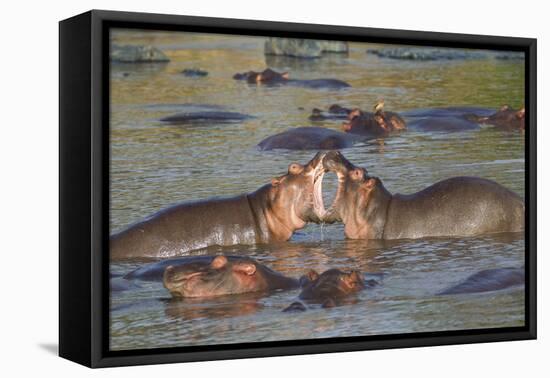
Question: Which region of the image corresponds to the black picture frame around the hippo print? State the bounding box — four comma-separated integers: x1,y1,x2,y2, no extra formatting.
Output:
59,10,537,367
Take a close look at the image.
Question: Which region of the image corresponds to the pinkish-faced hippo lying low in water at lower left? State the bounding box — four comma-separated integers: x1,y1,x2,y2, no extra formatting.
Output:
163,255,300,298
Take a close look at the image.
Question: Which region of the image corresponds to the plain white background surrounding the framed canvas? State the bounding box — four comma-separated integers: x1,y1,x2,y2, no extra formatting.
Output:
0,0,550,378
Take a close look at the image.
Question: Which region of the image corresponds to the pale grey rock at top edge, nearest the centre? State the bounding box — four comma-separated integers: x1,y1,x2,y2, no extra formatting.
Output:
264,38,348,58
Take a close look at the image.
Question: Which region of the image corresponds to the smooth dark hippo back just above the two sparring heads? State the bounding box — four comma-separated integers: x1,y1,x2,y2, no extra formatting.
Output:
258,127,361,151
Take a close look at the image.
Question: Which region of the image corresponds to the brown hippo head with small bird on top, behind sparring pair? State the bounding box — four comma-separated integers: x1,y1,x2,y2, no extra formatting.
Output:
342,101,407,137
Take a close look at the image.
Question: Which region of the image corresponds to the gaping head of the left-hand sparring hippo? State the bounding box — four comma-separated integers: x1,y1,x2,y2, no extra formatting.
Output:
266,152,326,236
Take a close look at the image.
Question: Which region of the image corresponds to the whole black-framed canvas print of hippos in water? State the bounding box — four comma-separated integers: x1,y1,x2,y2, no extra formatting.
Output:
59,10,536,367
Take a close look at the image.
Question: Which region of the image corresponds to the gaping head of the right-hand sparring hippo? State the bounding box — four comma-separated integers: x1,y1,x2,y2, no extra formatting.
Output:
323,151,385,239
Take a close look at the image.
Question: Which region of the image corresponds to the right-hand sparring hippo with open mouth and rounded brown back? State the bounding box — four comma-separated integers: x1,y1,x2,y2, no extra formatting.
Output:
323,151,525,239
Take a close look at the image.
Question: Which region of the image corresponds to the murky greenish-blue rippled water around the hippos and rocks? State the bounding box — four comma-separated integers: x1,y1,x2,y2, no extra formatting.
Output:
111,32,525,350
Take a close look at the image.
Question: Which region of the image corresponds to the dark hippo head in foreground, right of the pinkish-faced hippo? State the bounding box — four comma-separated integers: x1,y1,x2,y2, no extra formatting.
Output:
283,269,378,312
